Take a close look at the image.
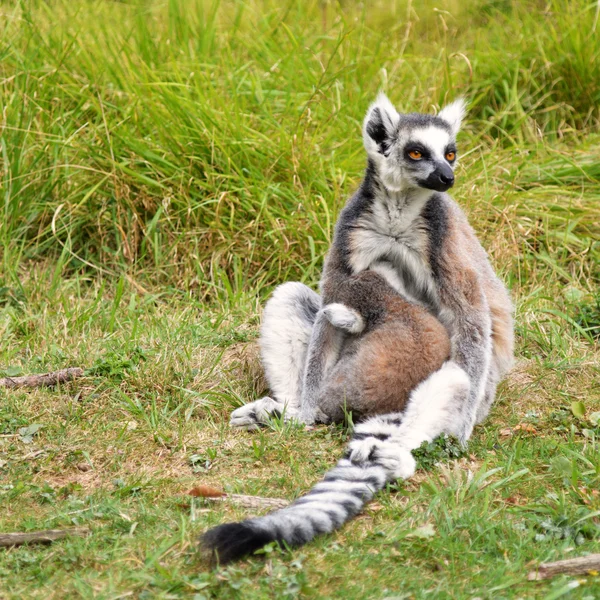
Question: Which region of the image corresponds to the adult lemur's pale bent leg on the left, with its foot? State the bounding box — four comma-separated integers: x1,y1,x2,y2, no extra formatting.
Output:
230,282,321,429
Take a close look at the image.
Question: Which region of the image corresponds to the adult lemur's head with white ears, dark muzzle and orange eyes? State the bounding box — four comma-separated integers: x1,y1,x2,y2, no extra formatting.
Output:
363,93,465,192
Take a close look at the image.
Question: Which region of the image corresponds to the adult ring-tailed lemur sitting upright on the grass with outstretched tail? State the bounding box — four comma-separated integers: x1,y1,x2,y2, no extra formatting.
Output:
203,95,513,562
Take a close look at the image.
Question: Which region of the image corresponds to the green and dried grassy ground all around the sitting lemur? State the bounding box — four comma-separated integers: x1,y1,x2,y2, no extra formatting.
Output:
0,0,600,600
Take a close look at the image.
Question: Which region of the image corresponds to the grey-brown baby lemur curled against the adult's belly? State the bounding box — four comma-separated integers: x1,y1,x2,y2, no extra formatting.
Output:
319,271,450,421
